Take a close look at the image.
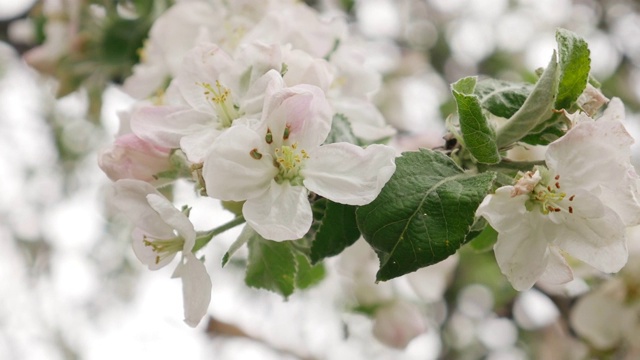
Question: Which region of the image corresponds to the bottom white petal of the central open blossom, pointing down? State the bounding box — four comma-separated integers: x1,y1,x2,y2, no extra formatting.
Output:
242,180,313,241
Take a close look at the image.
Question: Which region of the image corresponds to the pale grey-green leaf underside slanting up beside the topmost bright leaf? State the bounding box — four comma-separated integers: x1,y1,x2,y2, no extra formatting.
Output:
497,51,560,149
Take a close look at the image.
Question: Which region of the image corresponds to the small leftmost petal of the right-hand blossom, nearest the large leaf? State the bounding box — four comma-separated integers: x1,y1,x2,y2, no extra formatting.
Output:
476,186,529,232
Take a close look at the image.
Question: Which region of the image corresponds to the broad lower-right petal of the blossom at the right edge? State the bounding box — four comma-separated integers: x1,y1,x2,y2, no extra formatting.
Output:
554,202,629,273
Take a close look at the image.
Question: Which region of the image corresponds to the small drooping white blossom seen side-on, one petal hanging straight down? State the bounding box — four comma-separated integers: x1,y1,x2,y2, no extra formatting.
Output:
112,179,211,327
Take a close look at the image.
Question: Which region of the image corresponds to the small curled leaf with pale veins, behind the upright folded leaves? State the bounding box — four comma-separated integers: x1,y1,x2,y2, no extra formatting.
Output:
475,79,533,119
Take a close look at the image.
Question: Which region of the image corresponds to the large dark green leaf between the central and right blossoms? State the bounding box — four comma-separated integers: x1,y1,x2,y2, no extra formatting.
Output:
356,149,496,281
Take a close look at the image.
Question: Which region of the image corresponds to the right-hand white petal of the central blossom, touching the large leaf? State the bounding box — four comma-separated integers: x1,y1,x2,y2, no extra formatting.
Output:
300,143,396,205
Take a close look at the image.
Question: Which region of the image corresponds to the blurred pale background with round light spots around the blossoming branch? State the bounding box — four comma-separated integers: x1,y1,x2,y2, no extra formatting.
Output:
0,0,640,360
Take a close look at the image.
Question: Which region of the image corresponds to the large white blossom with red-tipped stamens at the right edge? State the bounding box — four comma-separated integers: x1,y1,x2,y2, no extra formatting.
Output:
476,99,640,290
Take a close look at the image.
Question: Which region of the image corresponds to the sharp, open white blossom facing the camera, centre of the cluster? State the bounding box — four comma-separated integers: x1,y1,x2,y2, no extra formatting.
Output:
203,85,395,240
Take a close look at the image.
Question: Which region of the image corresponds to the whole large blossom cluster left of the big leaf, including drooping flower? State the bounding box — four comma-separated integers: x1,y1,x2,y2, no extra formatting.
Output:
99,1,396,326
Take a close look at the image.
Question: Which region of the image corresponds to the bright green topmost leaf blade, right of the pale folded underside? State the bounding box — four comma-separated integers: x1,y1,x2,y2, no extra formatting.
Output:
555,29,591,109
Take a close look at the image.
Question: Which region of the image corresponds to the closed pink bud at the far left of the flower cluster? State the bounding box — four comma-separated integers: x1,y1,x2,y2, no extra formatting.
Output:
98,134,171,182
